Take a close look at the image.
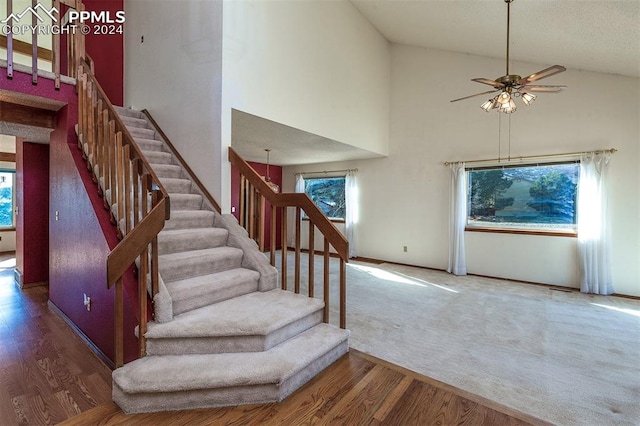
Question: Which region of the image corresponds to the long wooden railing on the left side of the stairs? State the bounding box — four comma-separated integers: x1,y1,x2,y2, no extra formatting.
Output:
77,60,170,367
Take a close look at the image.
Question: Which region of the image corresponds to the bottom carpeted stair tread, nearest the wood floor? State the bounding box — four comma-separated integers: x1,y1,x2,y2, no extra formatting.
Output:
113,322,349,394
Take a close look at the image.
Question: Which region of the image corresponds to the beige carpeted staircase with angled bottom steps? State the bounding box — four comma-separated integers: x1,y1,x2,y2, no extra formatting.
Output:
105,107,349,413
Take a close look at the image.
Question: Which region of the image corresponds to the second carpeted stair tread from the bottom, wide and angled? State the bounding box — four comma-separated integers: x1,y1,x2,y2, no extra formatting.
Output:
145,289,324,338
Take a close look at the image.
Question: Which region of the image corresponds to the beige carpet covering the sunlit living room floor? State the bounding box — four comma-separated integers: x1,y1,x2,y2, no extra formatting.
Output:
278,255,640,425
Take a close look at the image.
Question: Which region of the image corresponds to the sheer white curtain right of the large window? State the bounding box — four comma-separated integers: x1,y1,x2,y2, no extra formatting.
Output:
578,153,614,294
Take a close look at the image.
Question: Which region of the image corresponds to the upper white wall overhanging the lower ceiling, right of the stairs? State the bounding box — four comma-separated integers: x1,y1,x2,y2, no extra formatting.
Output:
223,0,390,210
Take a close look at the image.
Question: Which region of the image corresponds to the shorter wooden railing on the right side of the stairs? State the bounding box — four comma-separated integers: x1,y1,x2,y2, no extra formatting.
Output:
229,147,349,328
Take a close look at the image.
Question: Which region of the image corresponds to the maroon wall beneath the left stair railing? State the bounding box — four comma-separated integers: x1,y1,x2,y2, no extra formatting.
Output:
5,68,137,362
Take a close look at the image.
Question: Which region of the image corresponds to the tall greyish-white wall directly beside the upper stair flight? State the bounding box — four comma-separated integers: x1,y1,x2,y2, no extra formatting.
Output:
125,0,224,201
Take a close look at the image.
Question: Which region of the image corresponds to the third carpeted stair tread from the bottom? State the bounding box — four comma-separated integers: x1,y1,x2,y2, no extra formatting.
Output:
165,268,260,302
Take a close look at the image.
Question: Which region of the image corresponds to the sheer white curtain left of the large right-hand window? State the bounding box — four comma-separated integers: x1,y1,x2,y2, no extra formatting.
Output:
447,163,467,275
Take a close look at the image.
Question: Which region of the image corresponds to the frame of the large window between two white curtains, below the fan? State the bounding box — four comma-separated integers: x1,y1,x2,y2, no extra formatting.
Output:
465,160,580,238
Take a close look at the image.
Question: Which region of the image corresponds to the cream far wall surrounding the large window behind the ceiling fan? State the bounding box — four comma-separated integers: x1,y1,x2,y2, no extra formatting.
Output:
283,45,640,296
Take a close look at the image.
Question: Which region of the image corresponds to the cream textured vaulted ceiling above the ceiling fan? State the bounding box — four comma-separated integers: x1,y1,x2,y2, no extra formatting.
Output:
351,0,640,77
